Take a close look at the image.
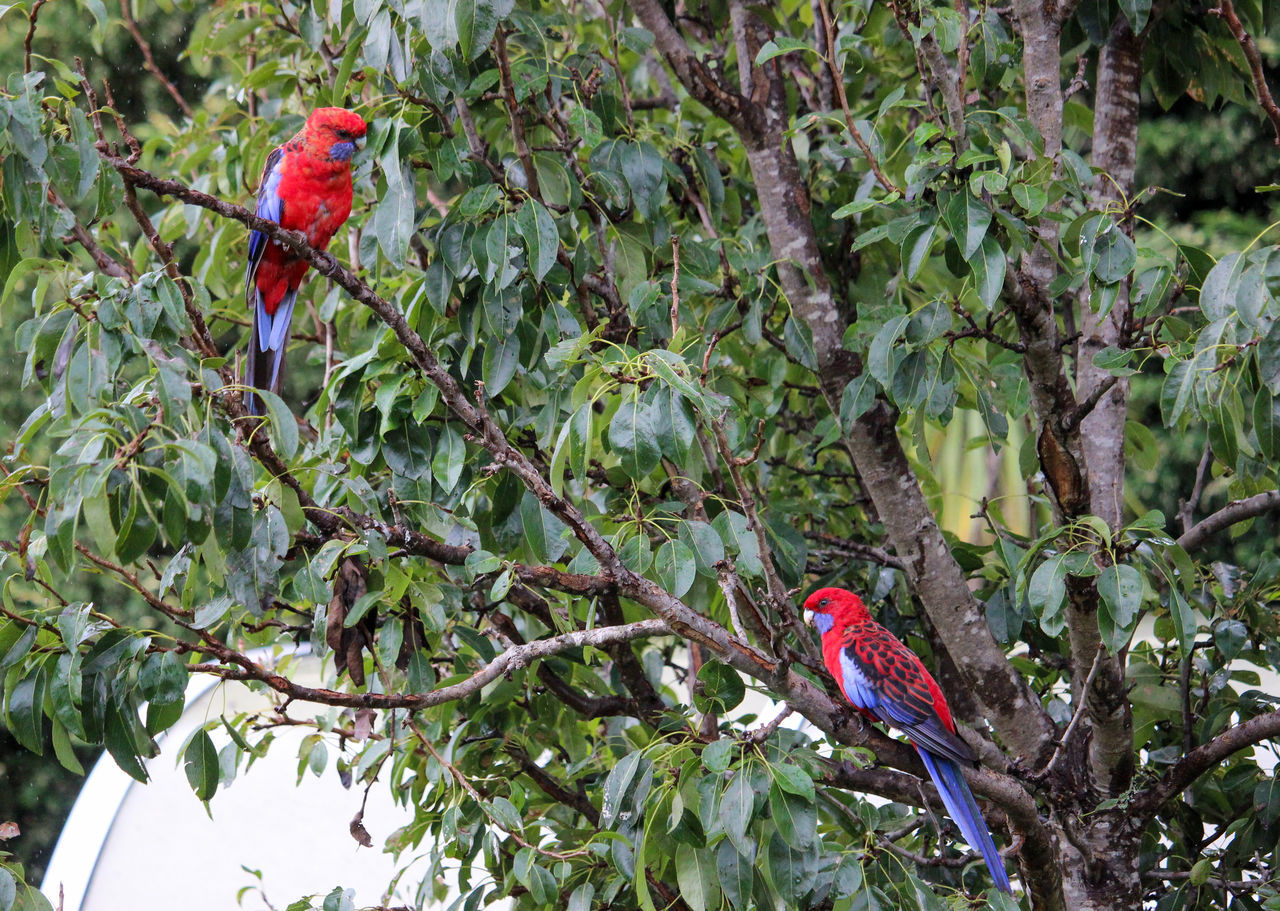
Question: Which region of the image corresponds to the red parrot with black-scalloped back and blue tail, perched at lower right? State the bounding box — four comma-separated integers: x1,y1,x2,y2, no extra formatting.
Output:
804,589,1010,892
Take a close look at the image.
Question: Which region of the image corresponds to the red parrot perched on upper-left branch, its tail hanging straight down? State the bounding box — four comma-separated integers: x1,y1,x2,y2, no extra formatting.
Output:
244,107,366,415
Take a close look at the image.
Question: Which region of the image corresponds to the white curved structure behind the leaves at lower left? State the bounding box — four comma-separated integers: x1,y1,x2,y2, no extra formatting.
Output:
41,650,416,911
